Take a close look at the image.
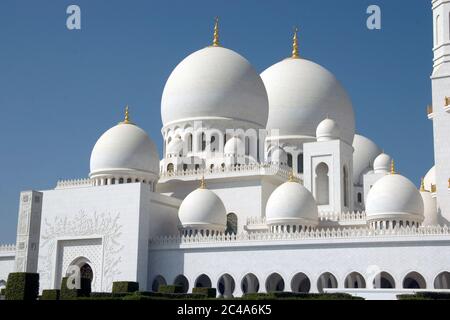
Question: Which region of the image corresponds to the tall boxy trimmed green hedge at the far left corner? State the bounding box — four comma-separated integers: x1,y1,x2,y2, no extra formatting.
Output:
5,272,39,300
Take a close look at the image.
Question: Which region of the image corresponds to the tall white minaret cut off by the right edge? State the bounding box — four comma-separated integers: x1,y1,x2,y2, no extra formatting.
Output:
429,0,450,223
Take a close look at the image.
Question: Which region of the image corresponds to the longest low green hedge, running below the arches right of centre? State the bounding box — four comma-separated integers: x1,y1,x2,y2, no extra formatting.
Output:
241,292,364,300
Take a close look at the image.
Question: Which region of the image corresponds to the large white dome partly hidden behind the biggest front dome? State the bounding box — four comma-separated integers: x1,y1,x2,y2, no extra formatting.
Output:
261,58,355,144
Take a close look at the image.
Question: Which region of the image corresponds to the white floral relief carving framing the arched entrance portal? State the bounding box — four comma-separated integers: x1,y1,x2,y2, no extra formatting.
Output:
38,210,123,291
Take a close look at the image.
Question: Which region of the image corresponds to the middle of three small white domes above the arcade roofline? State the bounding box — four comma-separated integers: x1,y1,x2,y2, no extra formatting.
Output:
266,182,319,226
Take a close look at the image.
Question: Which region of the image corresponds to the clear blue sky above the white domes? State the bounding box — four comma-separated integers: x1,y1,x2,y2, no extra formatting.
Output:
0,0,434,243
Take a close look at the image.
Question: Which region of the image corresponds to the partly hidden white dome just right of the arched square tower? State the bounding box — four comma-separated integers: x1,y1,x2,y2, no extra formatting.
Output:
353,134,382,185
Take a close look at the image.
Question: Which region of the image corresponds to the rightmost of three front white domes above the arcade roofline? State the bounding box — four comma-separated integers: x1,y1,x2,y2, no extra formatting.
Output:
366,174,424,222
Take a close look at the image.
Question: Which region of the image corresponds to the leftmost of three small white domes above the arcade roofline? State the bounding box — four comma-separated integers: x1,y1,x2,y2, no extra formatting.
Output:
178,188,227,232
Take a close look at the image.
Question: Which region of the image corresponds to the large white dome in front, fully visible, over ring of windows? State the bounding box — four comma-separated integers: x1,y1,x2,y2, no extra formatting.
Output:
161,47,269,127
